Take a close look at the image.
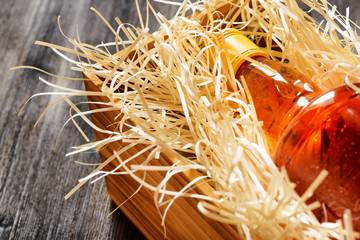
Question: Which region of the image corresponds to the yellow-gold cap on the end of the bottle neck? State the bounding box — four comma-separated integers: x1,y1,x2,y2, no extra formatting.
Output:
212,29,269,73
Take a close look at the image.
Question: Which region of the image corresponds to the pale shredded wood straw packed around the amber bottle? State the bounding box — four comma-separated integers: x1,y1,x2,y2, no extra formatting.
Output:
17,0,360,239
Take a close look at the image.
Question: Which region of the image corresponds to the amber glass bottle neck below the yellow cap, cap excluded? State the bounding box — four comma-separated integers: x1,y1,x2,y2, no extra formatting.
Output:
235,56,320,152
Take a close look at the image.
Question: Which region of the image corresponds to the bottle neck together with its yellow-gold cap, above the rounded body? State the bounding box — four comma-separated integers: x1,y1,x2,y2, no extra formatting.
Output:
212,29,320,152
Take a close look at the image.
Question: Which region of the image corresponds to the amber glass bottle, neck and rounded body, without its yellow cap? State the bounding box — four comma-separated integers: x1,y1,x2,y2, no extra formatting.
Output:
236,58,360,231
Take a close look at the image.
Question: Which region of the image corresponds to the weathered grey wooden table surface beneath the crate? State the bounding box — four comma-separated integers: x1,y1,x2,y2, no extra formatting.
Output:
0,0,360,239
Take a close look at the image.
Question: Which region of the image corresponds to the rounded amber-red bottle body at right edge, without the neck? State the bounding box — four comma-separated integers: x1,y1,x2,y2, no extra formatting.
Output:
273,84,360,231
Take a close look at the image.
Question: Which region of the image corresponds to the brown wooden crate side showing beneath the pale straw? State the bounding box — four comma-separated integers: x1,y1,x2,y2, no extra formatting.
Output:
84,75,239,240
